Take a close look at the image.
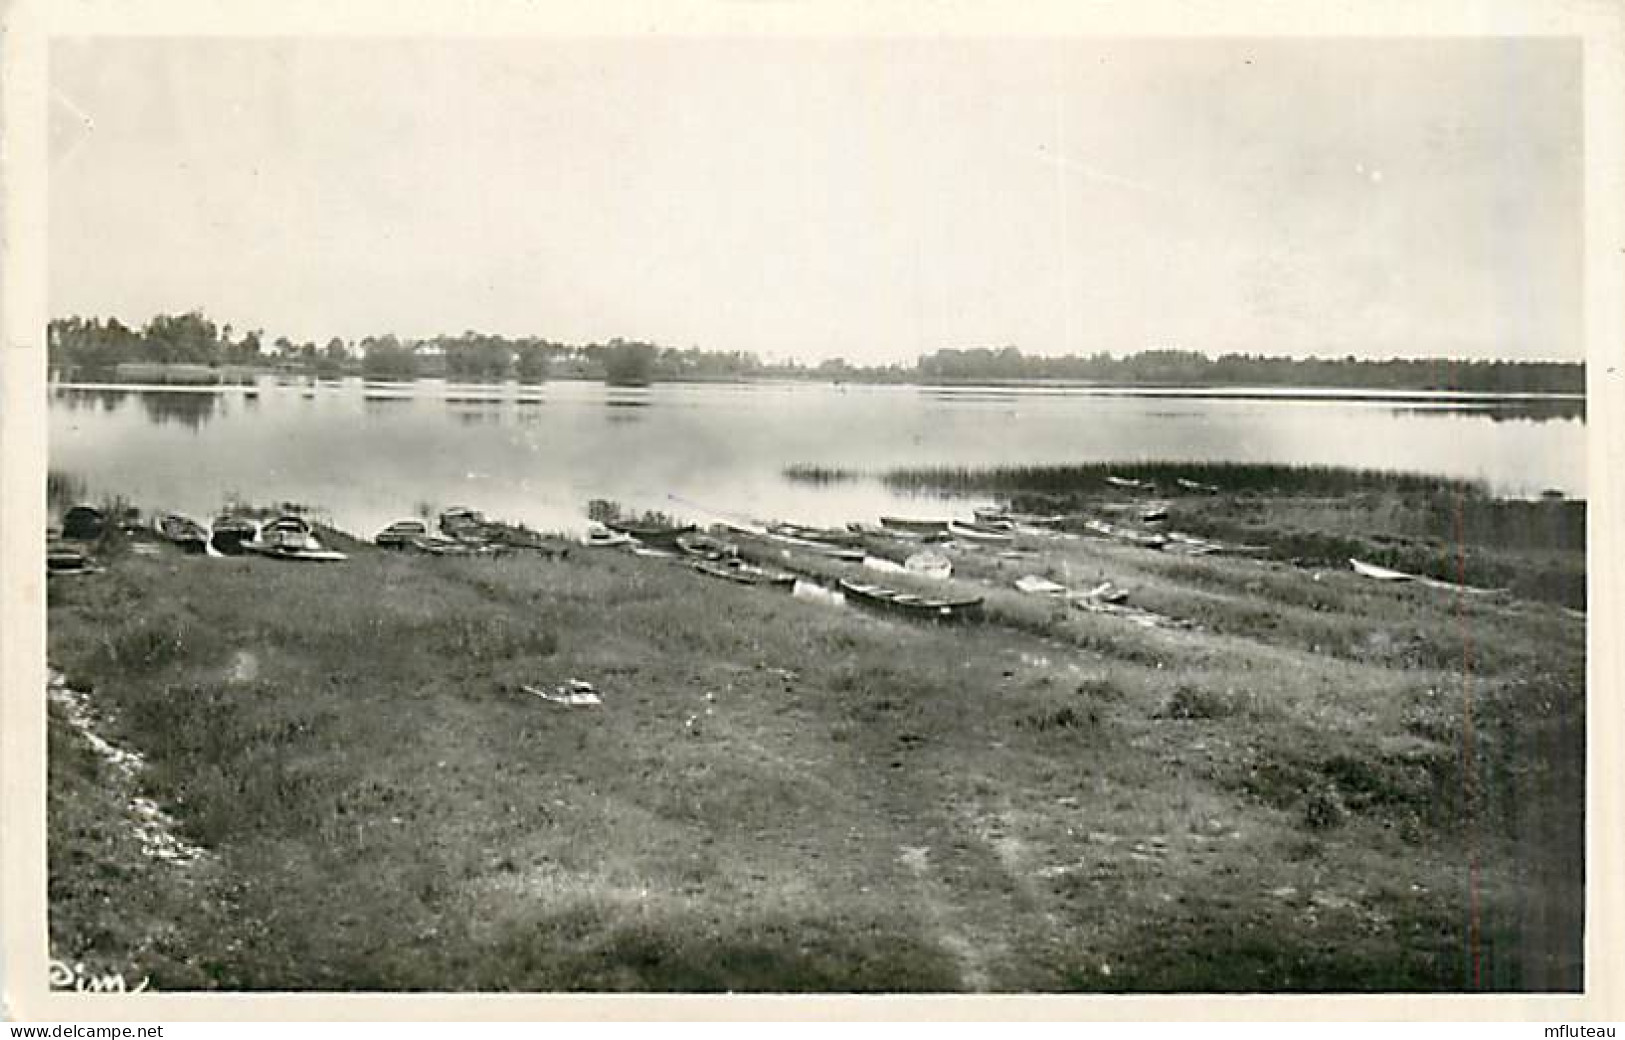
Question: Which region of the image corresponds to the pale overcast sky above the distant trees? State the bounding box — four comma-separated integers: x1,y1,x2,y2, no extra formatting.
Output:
50,39,1583,362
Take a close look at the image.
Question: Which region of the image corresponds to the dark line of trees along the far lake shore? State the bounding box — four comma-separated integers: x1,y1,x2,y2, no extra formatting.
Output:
47,310,1586,393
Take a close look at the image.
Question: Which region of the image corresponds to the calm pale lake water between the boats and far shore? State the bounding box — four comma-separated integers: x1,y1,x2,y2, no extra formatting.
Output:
49,377,1586,535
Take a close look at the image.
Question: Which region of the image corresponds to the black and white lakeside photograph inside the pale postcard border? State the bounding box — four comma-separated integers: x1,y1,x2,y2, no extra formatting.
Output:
8,5,1618,996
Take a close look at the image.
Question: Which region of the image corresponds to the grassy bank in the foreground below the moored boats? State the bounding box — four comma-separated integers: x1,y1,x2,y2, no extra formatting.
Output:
49,510,1584,991
